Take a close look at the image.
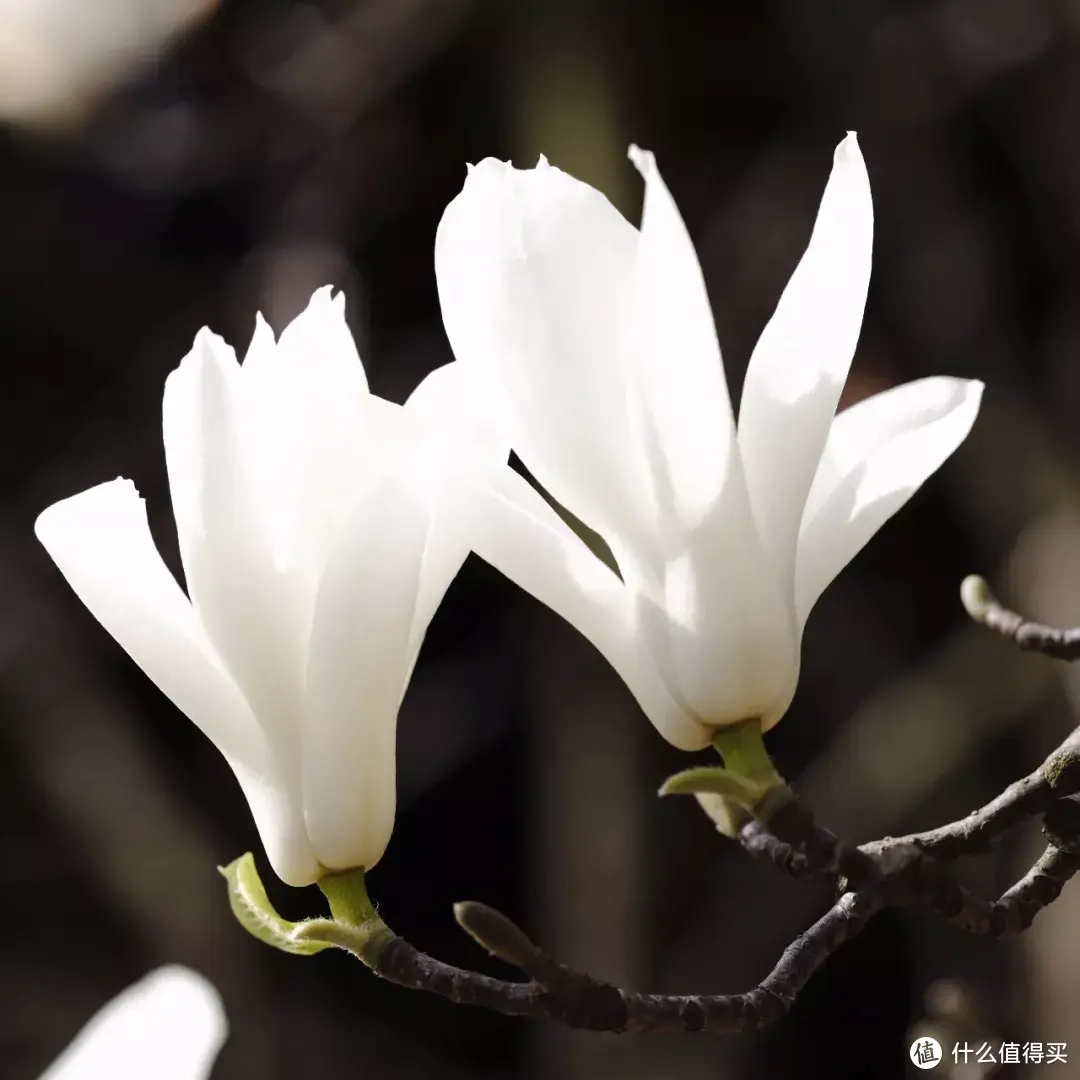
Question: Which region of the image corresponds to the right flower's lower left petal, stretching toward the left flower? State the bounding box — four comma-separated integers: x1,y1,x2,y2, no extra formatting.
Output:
458,468,711,750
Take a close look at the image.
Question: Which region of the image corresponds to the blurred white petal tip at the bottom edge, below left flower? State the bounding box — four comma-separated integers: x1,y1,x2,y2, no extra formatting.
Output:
41,966,228,1080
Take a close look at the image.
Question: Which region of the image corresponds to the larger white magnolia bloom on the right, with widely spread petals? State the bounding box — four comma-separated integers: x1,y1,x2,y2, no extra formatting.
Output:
435,135,982,750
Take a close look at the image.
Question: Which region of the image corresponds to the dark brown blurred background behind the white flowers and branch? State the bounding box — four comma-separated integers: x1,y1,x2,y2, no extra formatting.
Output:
0,0,1080,1080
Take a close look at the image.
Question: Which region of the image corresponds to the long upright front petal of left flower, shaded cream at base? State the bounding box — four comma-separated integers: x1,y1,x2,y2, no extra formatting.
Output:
303,474,430,869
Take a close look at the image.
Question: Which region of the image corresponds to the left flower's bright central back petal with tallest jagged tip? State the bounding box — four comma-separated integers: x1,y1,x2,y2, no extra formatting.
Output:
241,288,382,587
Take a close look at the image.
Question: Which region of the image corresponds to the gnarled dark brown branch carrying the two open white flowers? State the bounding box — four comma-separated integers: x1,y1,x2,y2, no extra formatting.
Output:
321,630,1080,1034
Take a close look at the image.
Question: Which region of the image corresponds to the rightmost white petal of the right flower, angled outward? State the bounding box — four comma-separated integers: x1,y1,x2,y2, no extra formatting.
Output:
796,377,983,625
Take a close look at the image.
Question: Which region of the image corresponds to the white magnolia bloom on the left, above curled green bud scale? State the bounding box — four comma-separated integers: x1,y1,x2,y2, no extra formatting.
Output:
36,288,498,886
